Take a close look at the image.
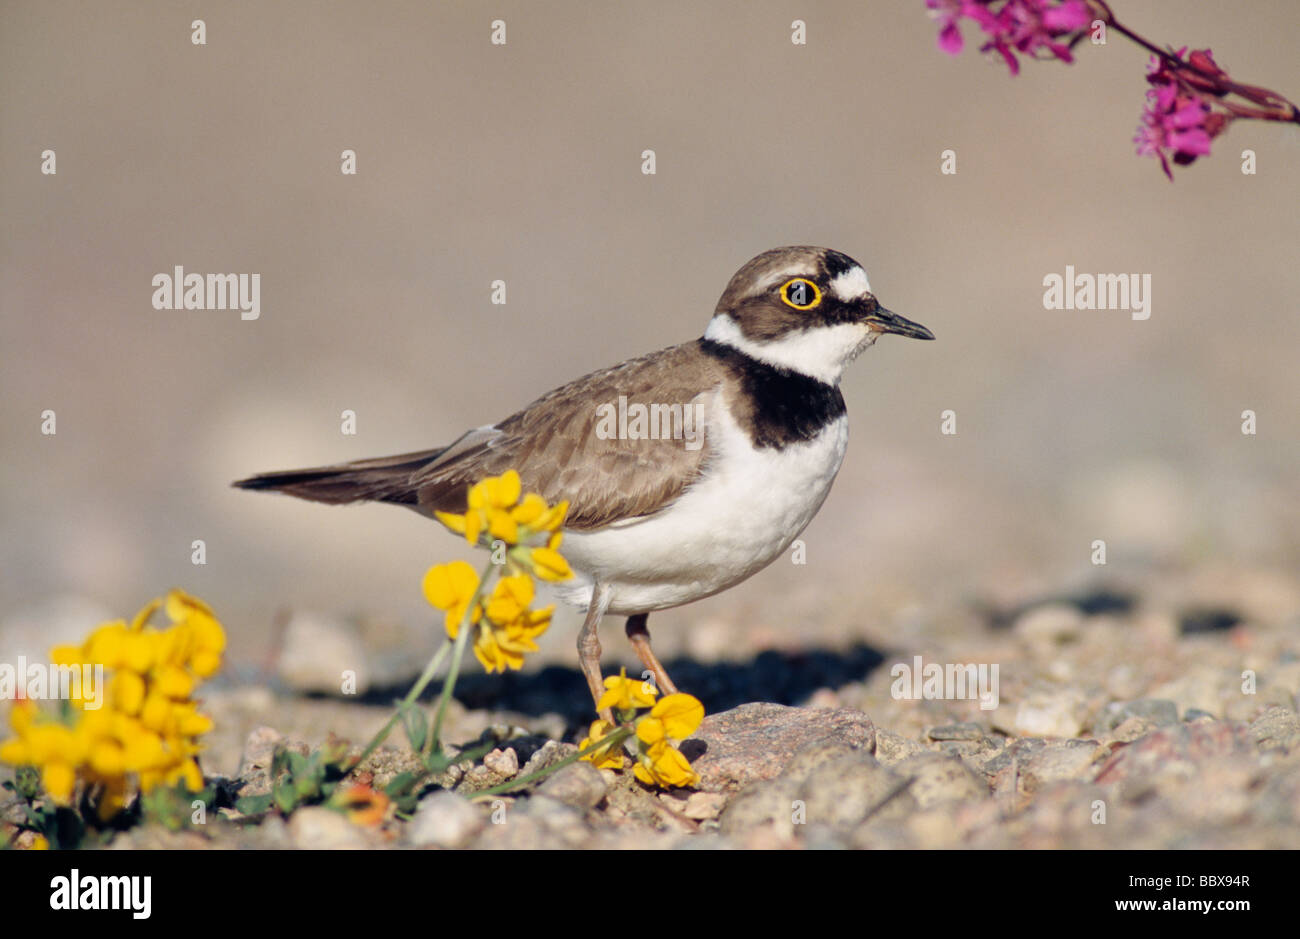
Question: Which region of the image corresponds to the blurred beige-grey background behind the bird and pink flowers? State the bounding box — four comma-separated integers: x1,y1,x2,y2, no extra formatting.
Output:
0,0,1300,680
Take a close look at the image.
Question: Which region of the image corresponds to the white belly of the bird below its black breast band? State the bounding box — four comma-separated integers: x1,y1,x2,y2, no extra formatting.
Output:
559,408,849,615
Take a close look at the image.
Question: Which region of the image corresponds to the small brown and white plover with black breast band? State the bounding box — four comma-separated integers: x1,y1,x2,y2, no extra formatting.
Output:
233,246,935,701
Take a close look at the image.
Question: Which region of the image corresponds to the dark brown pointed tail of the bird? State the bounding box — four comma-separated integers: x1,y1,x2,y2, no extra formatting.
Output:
231,447,447,505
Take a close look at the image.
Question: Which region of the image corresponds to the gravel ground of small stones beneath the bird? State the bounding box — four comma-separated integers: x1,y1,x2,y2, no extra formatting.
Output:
5,556,1300,848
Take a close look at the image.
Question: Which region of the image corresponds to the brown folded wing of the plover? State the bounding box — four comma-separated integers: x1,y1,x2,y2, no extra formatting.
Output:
411,342,722,531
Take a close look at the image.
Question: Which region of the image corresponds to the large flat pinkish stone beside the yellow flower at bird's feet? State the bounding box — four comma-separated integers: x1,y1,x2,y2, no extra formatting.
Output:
681,704,876,792
